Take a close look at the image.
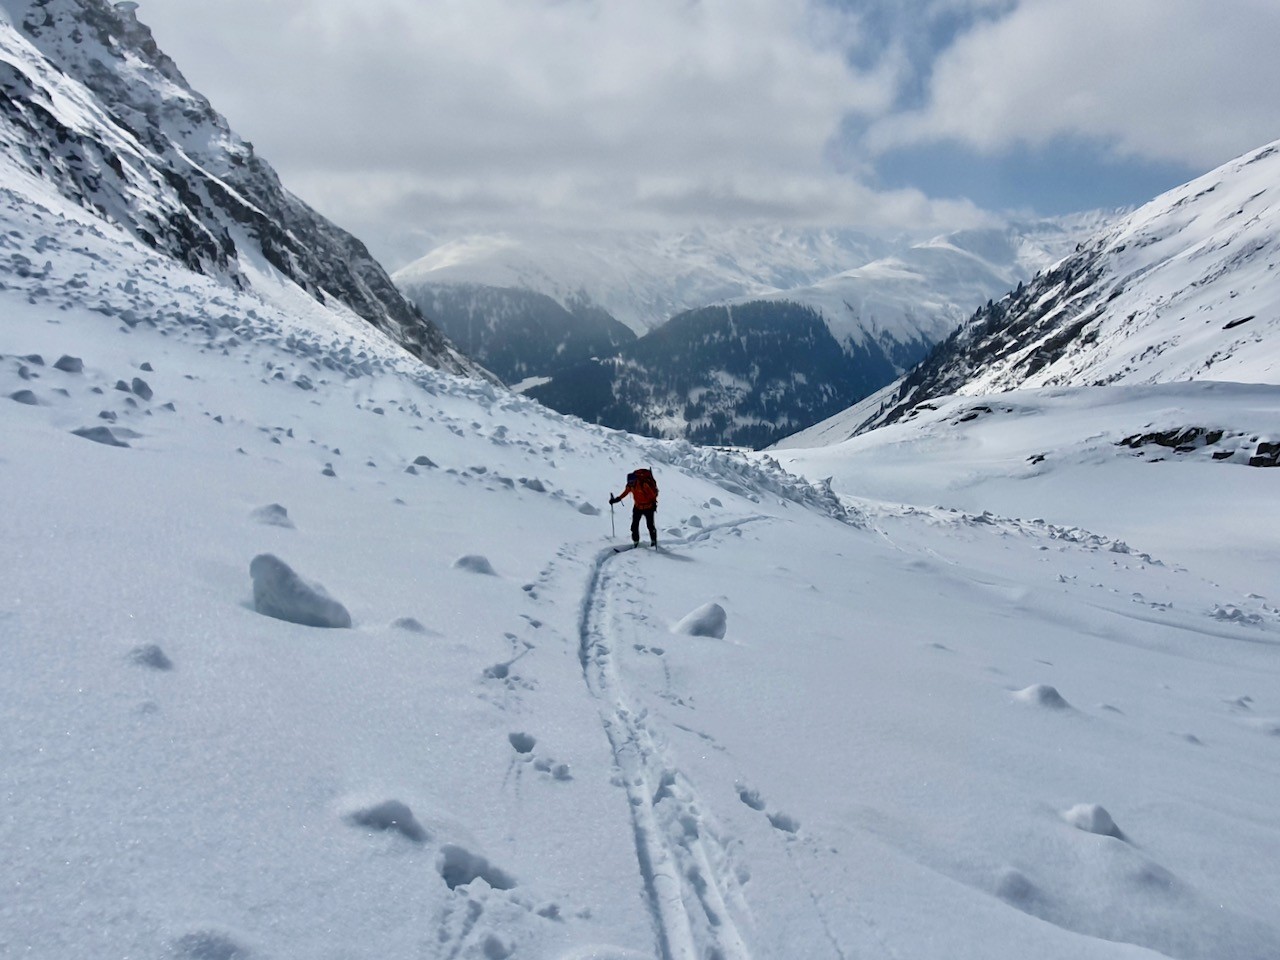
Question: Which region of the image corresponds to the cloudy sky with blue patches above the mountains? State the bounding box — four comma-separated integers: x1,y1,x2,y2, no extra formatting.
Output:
138,0,1280,269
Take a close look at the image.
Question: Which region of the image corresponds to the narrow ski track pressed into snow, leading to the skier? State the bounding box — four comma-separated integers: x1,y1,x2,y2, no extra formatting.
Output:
579,527,767,960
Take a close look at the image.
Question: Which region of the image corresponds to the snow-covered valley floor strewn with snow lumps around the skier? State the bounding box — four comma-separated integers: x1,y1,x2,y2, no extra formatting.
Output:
0,167,1280,960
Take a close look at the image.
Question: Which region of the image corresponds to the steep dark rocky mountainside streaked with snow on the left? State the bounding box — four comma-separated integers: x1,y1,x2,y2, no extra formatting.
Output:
0,0,480,374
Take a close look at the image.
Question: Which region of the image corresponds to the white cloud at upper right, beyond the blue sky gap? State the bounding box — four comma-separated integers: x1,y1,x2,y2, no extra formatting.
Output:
867,0,1280,168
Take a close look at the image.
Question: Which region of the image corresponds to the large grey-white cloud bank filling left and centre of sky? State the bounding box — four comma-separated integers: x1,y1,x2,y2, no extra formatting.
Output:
140,0,975,256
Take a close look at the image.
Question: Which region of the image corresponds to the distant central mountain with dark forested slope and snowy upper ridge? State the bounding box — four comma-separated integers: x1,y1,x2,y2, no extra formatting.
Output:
530,216,1098,447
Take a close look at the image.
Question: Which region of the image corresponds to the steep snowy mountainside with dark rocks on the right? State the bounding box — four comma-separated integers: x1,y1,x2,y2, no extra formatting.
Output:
787,142,1280,447
